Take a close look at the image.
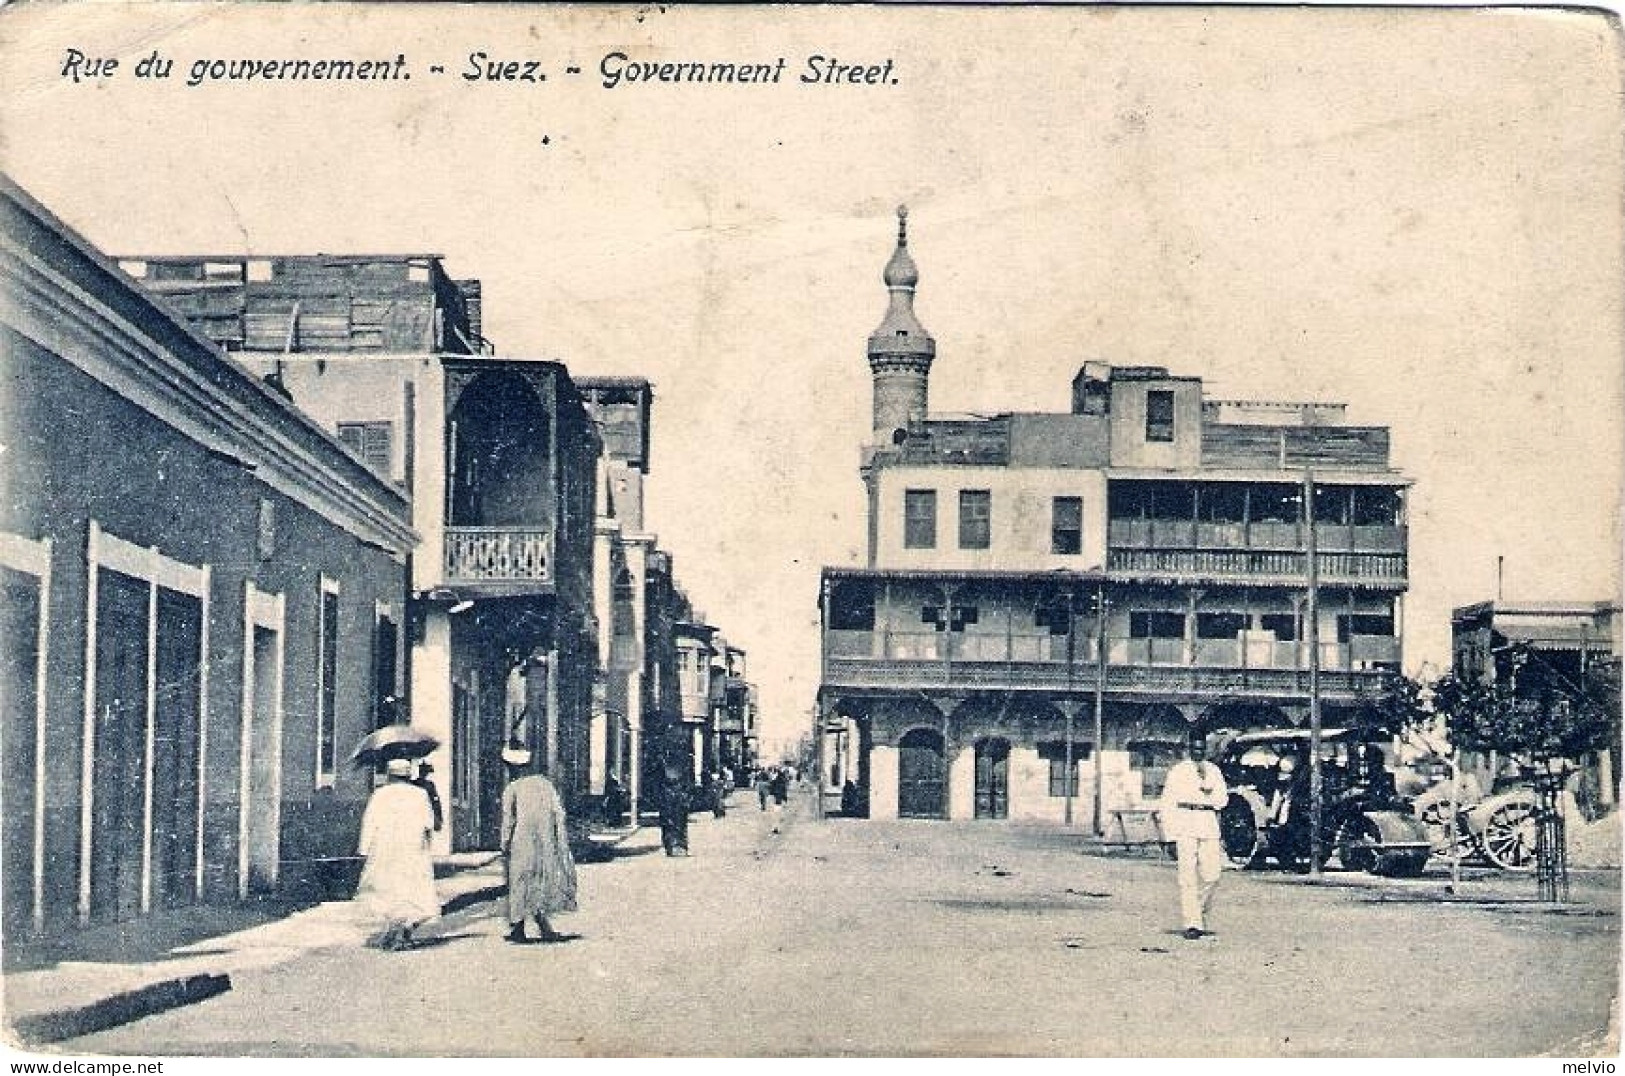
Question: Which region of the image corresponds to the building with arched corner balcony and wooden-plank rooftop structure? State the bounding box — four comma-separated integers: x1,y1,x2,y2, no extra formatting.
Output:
124,255,600,850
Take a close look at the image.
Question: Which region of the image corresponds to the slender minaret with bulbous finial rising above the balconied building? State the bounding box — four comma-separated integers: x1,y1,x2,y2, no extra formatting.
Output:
869,205,936,447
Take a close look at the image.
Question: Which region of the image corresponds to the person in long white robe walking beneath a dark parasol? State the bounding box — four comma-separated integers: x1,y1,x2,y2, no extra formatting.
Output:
356,759,440,949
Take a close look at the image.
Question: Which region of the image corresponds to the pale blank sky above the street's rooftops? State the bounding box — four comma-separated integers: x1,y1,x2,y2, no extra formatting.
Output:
0,3,1625,754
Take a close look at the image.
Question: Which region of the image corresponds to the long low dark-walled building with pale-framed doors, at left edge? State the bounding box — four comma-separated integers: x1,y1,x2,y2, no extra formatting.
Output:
0,180,416,944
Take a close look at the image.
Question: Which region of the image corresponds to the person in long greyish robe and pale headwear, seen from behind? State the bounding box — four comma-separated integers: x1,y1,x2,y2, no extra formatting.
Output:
502,744,575,944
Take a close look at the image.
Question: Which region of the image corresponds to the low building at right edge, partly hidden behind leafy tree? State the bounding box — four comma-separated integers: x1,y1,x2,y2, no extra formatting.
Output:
1450,601,1625,809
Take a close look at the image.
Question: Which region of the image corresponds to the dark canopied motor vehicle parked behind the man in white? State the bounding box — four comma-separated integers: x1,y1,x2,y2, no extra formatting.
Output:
1214,728,1430,876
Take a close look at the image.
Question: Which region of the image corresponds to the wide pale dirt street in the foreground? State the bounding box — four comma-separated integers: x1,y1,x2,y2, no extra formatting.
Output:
63,793,1619,1056
